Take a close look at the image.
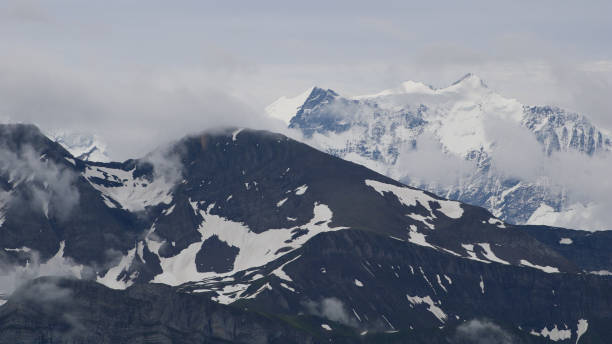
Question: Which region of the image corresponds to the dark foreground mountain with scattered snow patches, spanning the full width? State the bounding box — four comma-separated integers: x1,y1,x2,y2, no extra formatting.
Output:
0,122,612,343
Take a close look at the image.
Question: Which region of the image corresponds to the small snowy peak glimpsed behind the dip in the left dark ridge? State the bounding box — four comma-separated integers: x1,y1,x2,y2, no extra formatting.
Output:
47,131,111,162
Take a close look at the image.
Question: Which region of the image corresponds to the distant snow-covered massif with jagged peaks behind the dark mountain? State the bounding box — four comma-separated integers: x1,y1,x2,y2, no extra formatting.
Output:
266,74,612,230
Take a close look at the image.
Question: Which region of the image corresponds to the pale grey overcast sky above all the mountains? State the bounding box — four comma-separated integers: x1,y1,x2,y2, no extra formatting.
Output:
0,0,612,158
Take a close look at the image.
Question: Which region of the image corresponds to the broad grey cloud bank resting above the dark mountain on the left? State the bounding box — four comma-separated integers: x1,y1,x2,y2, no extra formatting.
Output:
0,50,280,160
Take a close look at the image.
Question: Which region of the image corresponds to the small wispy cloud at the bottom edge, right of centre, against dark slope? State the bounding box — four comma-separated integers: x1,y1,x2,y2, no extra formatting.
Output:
453,319,519,344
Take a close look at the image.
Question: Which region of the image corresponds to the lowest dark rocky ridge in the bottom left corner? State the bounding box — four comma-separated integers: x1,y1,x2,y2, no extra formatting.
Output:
0,278,314,344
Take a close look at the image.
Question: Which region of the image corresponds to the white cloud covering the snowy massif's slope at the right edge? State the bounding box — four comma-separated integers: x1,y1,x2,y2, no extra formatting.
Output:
485,115,612,230
